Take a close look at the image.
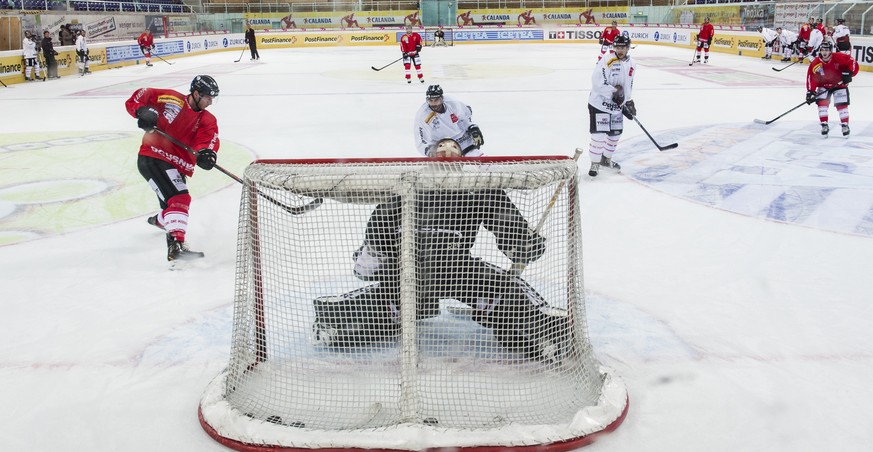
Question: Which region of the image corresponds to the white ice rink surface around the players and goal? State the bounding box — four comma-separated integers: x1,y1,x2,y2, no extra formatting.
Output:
0,40,873,452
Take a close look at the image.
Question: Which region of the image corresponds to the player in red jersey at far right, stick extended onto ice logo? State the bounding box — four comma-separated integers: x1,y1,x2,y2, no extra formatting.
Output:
806,41,859,136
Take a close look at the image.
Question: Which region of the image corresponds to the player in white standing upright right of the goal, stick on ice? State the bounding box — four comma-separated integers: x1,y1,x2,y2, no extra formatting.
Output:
588,36,637,177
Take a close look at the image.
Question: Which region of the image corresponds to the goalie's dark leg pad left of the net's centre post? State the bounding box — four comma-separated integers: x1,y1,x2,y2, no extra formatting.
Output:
312,284,400,347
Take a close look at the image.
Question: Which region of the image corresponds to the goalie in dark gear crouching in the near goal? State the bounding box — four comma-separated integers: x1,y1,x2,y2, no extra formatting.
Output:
313,139,569,361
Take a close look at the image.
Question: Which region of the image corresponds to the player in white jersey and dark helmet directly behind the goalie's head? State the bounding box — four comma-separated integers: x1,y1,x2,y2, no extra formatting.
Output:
413,85,485,157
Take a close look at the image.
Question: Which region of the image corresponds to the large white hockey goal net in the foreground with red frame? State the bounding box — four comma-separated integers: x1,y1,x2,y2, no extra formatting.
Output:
199,157,628,451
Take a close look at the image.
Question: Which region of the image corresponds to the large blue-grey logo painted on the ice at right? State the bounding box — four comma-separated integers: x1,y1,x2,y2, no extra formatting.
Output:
621,121,873,237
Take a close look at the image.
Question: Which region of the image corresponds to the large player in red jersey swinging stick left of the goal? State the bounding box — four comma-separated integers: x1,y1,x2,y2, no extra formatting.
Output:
125,75,219,261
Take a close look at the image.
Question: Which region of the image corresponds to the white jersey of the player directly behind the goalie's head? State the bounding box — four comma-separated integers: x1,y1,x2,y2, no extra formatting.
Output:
413,97,482,157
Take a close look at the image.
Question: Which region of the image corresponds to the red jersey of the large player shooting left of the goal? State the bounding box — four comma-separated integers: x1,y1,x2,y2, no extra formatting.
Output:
124,88,219,176
